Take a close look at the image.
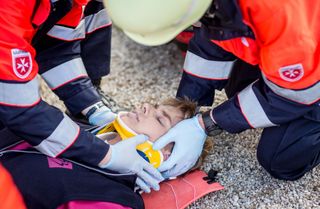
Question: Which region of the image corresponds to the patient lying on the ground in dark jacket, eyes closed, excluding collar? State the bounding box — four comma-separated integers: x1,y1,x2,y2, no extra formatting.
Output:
0,99,210,209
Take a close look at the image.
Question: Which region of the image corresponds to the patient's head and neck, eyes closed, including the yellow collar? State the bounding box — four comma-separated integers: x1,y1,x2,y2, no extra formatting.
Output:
93,99,212,174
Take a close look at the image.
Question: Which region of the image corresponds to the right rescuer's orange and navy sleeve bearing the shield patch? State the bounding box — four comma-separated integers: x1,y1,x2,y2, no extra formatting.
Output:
212,1,320,133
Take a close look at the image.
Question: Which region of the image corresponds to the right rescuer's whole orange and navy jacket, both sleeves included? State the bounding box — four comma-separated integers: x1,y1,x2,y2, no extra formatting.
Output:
178,0,320,132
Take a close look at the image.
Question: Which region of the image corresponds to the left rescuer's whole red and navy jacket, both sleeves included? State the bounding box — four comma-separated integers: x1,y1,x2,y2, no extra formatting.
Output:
0,0,111,165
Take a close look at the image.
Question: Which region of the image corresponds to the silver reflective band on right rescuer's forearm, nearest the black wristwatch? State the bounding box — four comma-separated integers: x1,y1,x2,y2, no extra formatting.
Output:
238,83,276,128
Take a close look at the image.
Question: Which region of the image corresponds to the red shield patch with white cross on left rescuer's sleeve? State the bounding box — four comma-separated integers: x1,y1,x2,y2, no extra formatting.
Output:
11,49,32,79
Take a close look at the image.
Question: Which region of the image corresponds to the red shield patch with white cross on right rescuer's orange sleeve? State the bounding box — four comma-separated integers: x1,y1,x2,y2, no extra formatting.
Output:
279,63,304,82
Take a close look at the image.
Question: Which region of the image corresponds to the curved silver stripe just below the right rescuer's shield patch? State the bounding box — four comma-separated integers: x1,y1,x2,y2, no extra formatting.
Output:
263,75,320,104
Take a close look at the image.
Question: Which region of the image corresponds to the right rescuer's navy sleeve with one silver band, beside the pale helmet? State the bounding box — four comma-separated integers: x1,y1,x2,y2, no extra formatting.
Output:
177,26,236,106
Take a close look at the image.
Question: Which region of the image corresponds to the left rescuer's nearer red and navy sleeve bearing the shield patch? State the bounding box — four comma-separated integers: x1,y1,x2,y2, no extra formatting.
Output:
0,0,109,165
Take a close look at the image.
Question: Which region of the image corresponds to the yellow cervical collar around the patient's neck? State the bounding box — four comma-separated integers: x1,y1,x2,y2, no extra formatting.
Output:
96,112,163,168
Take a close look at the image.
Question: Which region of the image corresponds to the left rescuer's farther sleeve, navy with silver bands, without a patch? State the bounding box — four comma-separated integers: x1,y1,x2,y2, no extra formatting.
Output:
33,1,105,115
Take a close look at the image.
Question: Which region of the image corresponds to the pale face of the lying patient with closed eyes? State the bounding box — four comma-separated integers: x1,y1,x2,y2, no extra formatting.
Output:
121,103,184,142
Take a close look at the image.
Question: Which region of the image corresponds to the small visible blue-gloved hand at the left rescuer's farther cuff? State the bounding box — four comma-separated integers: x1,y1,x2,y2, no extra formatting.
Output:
86,102,116,126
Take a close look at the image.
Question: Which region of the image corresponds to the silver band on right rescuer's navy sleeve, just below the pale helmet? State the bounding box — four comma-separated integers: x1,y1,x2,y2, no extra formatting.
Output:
183,51,234,79
